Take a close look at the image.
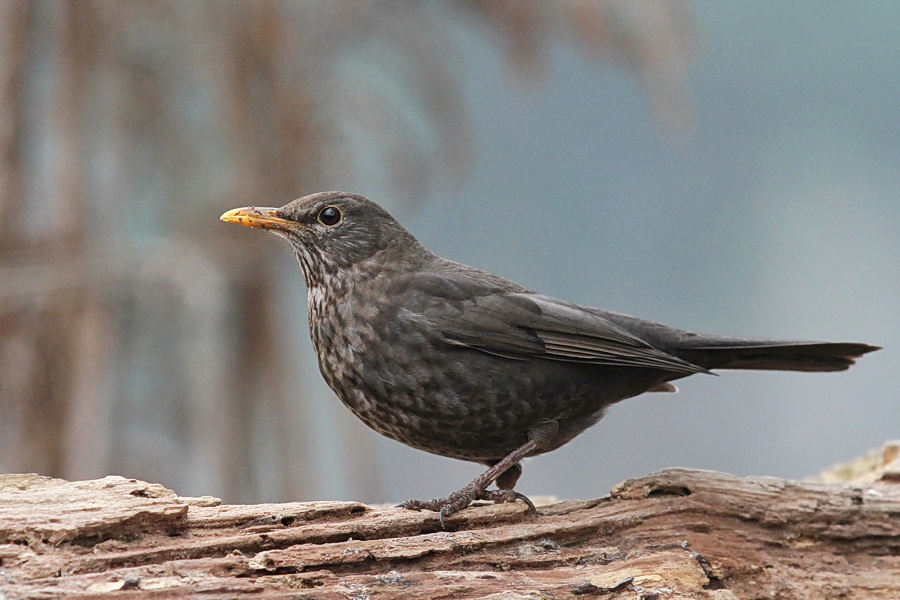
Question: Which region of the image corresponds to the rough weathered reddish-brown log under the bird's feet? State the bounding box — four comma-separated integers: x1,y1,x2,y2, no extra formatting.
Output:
0,442,900,600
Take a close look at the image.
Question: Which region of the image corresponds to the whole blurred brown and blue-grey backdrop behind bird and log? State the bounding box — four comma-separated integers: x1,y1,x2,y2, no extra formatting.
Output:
0,0,900,502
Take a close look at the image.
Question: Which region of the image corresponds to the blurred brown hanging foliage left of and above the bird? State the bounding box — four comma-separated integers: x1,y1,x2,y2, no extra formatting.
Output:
0,0,692,501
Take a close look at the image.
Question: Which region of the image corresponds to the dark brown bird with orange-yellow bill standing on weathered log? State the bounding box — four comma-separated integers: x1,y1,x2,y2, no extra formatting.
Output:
220,191,880,525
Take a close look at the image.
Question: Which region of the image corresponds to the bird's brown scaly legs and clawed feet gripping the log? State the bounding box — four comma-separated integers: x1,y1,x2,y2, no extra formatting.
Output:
400,421,558,527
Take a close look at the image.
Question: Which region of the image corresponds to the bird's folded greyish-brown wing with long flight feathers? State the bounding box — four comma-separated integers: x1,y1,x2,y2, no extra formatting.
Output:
403,272,706,373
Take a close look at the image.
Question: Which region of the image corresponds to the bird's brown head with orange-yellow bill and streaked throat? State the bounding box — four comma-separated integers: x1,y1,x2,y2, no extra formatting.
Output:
220,192,427,286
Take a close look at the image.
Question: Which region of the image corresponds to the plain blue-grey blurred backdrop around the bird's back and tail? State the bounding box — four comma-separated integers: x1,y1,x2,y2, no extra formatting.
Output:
325,1,900,501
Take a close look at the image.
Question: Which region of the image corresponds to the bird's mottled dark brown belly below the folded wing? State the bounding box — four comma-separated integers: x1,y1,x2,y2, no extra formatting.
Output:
313,314,643,461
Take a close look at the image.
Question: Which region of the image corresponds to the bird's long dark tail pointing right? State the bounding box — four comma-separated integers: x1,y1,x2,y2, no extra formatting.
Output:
677,336,881,371
